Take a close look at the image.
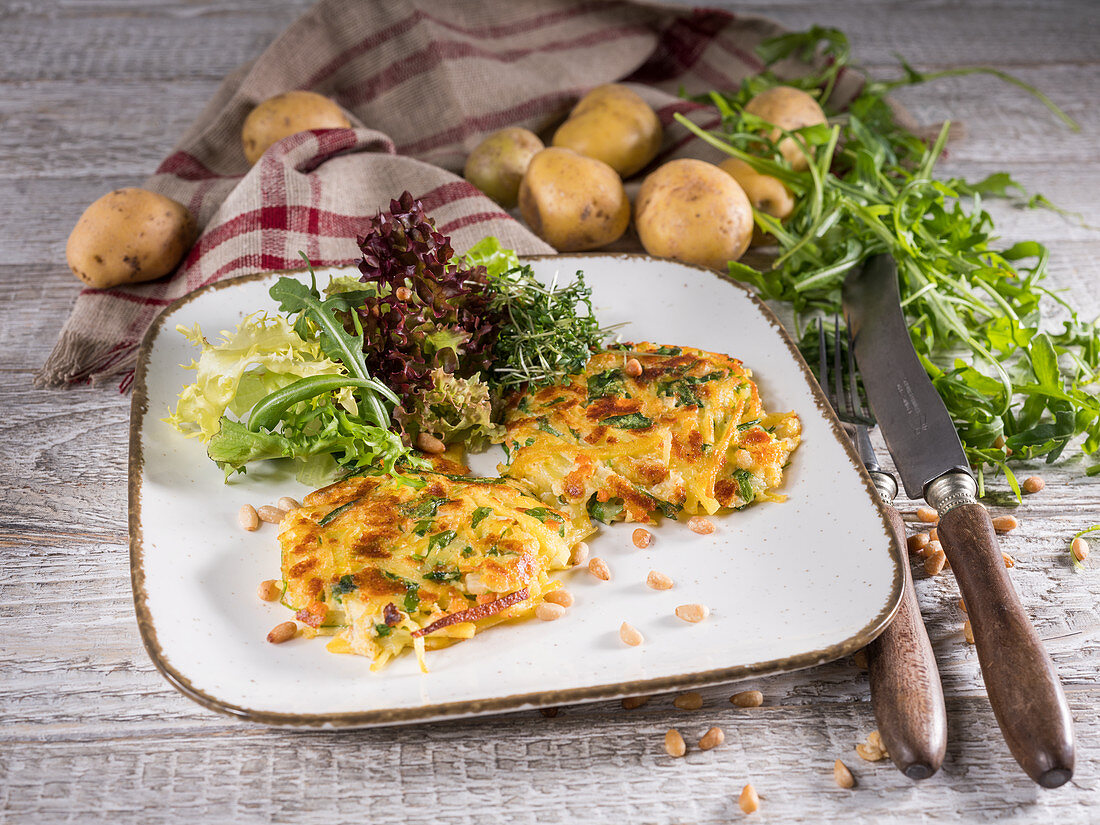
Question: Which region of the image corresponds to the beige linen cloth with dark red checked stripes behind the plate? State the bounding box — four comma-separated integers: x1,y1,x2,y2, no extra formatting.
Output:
37,0,858,388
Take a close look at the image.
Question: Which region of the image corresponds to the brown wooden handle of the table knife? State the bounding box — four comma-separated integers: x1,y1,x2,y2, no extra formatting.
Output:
937,504,1074,788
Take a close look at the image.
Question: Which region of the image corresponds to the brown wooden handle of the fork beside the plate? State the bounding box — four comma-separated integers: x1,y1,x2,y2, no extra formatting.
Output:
867,504,947,780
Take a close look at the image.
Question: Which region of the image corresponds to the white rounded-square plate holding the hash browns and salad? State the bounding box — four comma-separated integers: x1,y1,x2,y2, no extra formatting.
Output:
130,255,906,727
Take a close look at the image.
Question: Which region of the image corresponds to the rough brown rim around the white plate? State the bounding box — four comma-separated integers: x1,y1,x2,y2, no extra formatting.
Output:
128,252,909,729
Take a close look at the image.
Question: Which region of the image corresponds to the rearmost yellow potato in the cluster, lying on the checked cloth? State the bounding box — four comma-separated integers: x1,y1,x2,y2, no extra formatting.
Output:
553,84,663,177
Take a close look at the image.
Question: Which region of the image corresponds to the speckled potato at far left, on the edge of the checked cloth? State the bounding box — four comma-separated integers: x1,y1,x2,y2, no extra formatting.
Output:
65,189,196,289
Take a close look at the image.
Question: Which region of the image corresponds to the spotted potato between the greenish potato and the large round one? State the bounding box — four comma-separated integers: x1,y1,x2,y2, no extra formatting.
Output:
519,146,633,252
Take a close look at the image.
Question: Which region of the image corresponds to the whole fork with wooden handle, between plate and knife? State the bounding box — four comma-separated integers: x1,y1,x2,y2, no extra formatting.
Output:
817,318,947,780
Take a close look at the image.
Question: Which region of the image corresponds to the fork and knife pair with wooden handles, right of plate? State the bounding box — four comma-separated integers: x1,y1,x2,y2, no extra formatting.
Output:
818,255,1074,788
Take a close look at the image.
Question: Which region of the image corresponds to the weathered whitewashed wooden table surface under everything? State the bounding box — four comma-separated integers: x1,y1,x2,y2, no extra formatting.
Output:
0,0,1100,825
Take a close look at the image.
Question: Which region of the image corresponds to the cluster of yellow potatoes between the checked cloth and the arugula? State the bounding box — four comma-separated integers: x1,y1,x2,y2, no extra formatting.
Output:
464,84,825,270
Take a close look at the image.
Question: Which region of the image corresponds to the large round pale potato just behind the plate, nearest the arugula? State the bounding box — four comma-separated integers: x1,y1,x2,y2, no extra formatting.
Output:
635,158,752,270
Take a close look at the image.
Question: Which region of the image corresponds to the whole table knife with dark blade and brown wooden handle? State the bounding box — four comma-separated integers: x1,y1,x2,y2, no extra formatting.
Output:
843,255,1075,788
